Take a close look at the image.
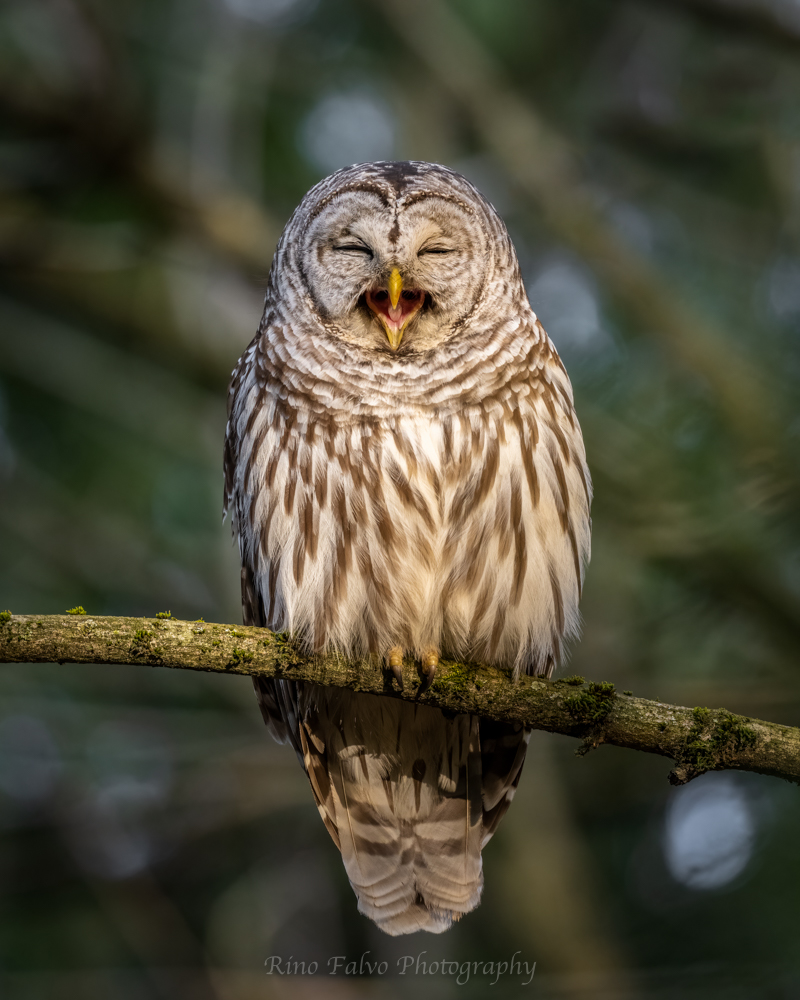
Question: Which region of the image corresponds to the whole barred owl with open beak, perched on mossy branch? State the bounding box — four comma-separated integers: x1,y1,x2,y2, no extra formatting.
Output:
225,162,591,934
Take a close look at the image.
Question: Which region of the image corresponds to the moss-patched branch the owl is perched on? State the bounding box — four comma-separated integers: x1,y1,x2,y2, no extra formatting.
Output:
0,607,800,785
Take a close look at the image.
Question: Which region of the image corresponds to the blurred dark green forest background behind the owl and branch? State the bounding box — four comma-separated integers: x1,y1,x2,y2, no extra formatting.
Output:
0,0,800,1000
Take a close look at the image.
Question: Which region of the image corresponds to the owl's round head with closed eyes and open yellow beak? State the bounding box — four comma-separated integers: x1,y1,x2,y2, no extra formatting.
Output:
273,162,525,359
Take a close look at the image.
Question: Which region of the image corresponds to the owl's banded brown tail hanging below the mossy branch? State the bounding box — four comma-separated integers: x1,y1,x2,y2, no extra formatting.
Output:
257,681,528,935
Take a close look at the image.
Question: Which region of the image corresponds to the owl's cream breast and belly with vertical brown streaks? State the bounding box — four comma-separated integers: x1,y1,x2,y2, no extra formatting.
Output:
232,370,590,675
